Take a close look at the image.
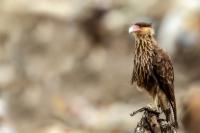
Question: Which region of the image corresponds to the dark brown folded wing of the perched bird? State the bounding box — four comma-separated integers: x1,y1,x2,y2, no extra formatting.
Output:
153,49,177,127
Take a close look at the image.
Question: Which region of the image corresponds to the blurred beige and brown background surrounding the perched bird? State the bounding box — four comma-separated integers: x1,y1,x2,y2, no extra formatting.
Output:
0,0,200,133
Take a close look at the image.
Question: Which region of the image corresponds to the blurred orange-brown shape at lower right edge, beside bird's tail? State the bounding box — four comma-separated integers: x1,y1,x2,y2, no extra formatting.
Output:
182,84,200,133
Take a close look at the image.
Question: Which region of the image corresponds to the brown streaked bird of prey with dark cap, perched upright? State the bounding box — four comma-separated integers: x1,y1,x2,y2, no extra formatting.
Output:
128,22,178,128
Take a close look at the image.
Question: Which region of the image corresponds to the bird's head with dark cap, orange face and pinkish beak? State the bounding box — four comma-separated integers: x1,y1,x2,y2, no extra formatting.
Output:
128,22,154,37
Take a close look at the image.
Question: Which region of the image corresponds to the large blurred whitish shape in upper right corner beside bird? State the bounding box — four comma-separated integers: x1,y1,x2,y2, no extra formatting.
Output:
158,0,200,55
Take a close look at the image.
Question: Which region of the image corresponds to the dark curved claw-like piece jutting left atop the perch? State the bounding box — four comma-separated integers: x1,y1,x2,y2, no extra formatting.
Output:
130,105,160,116
